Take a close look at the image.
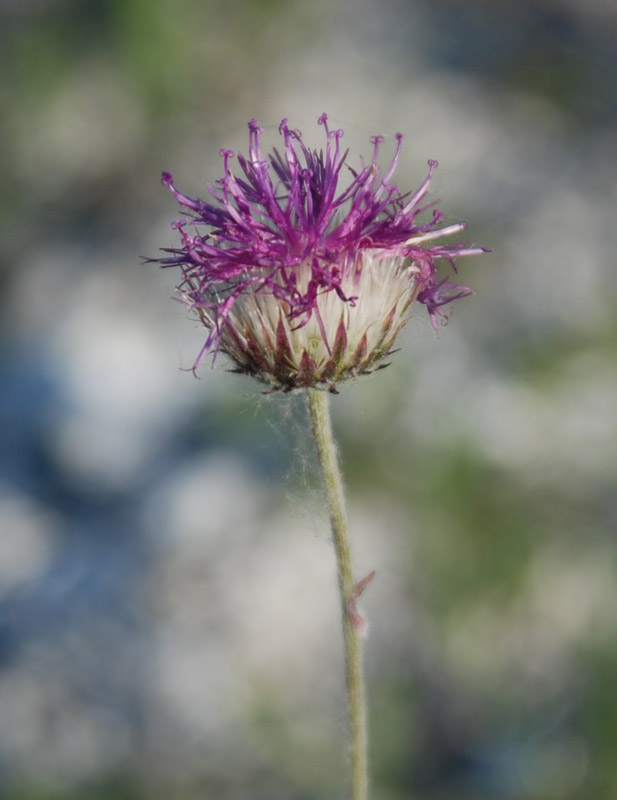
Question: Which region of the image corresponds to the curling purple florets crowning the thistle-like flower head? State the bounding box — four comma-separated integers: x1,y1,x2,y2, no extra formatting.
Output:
158,114,485,366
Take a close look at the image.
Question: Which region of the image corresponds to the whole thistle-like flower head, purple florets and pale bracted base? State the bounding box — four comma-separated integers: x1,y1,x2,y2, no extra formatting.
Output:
157,114,485,391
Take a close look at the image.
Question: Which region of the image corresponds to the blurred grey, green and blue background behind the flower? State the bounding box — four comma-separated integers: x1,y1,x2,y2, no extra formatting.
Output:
0,0,617,800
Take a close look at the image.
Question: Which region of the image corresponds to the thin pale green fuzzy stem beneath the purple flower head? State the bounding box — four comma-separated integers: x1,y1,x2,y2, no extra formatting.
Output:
307,389,368,800
